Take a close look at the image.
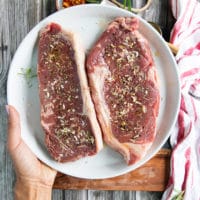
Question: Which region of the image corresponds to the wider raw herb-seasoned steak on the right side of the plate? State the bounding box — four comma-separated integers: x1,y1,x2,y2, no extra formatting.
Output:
87,17,160,165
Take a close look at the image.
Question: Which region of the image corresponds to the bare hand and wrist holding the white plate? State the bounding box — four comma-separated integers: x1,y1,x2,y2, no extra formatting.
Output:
6,105,57,200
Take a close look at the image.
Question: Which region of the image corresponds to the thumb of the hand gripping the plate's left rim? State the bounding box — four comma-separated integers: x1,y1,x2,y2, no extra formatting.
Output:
6,105,21,154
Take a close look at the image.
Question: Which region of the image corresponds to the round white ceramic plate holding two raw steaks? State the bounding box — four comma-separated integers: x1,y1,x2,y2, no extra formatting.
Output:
7,4,180,179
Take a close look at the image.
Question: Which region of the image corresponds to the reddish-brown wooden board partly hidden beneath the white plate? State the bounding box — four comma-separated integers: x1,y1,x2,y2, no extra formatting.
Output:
54,149,171,191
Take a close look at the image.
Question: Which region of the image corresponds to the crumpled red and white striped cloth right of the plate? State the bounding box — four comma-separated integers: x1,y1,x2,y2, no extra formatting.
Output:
162,0,200,200
